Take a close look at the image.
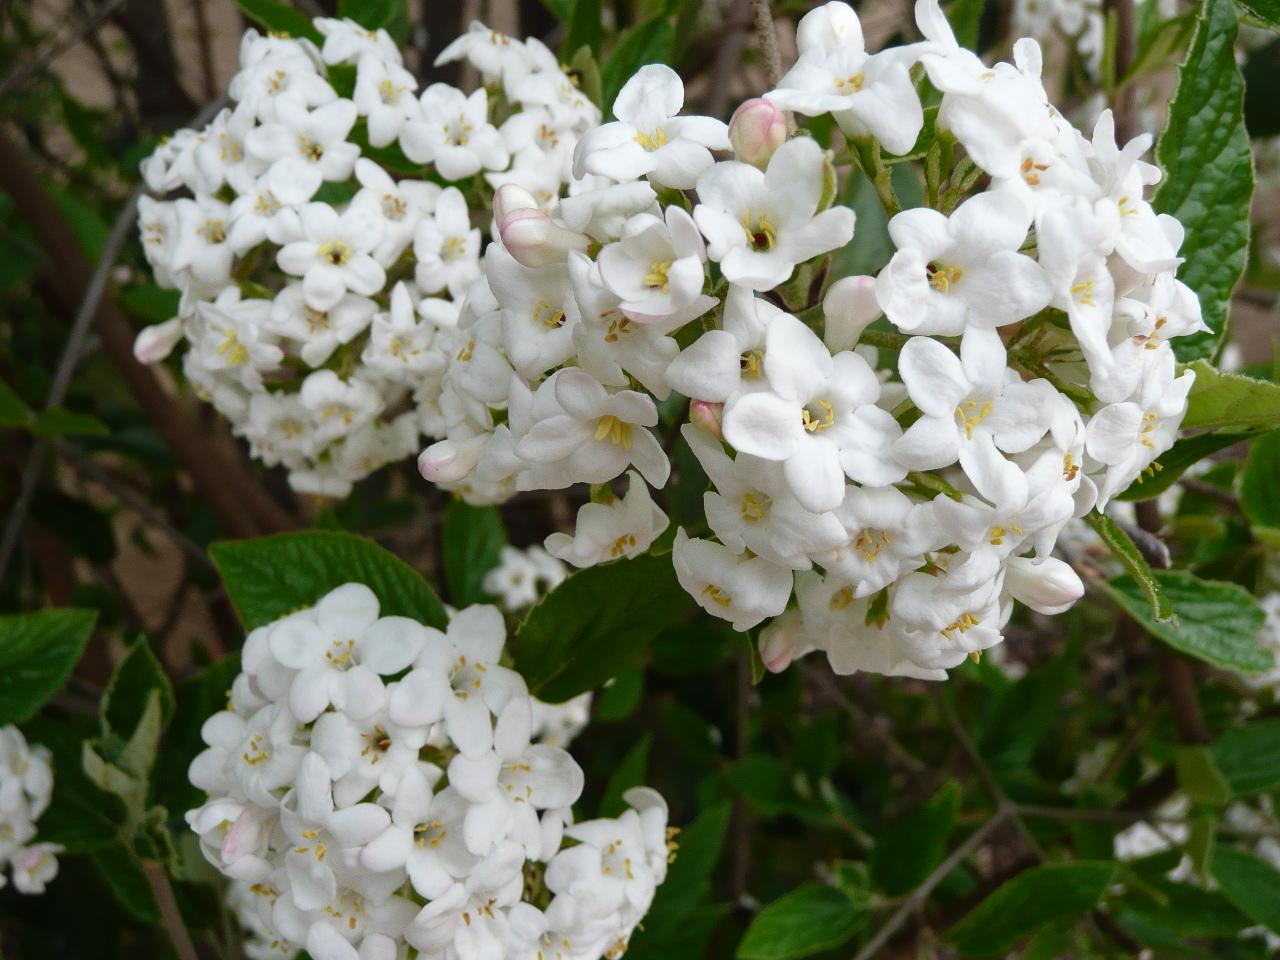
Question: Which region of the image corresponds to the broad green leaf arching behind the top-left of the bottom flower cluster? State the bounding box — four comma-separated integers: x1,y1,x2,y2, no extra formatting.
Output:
209,530,448,630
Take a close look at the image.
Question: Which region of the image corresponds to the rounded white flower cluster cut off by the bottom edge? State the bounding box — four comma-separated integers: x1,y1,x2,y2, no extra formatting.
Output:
187,584,672,960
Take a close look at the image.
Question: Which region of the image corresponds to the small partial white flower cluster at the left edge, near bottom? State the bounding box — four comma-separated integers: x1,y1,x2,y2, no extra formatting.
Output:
0,727,63,893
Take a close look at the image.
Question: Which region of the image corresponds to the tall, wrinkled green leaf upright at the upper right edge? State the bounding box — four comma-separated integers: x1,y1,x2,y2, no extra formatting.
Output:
1151,0,1253,360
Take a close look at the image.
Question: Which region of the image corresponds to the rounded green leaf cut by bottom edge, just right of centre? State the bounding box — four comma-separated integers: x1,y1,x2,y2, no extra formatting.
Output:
737,883,867,960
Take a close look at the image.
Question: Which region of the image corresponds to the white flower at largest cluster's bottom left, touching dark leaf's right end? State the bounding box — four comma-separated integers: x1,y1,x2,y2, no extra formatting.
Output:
671,529,791,632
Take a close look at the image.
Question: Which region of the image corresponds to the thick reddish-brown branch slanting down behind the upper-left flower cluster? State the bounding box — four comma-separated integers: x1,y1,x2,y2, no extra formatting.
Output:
0,134,296,555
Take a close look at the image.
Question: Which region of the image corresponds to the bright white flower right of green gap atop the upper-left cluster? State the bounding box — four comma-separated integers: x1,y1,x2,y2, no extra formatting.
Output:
399,83,511,180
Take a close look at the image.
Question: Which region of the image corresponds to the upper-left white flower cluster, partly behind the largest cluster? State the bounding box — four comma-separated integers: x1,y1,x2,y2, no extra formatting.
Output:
134,19,599,497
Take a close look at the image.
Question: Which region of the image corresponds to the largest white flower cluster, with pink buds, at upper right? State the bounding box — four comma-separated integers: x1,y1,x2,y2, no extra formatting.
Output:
419,0,1204,678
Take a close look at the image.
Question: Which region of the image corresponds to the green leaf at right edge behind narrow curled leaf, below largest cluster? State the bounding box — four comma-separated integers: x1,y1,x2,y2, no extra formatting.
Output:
1102,570,1274,673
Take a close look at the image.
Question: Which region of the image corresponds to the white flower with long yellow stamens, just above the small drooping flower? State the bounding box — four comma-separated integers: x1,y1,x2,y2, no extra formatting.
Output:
516,370,671,489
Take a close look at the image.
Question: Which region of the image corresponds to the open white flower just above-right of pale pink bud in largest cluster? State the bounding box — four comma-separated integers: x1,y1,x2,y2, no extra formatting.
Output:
876,193,1052,335
